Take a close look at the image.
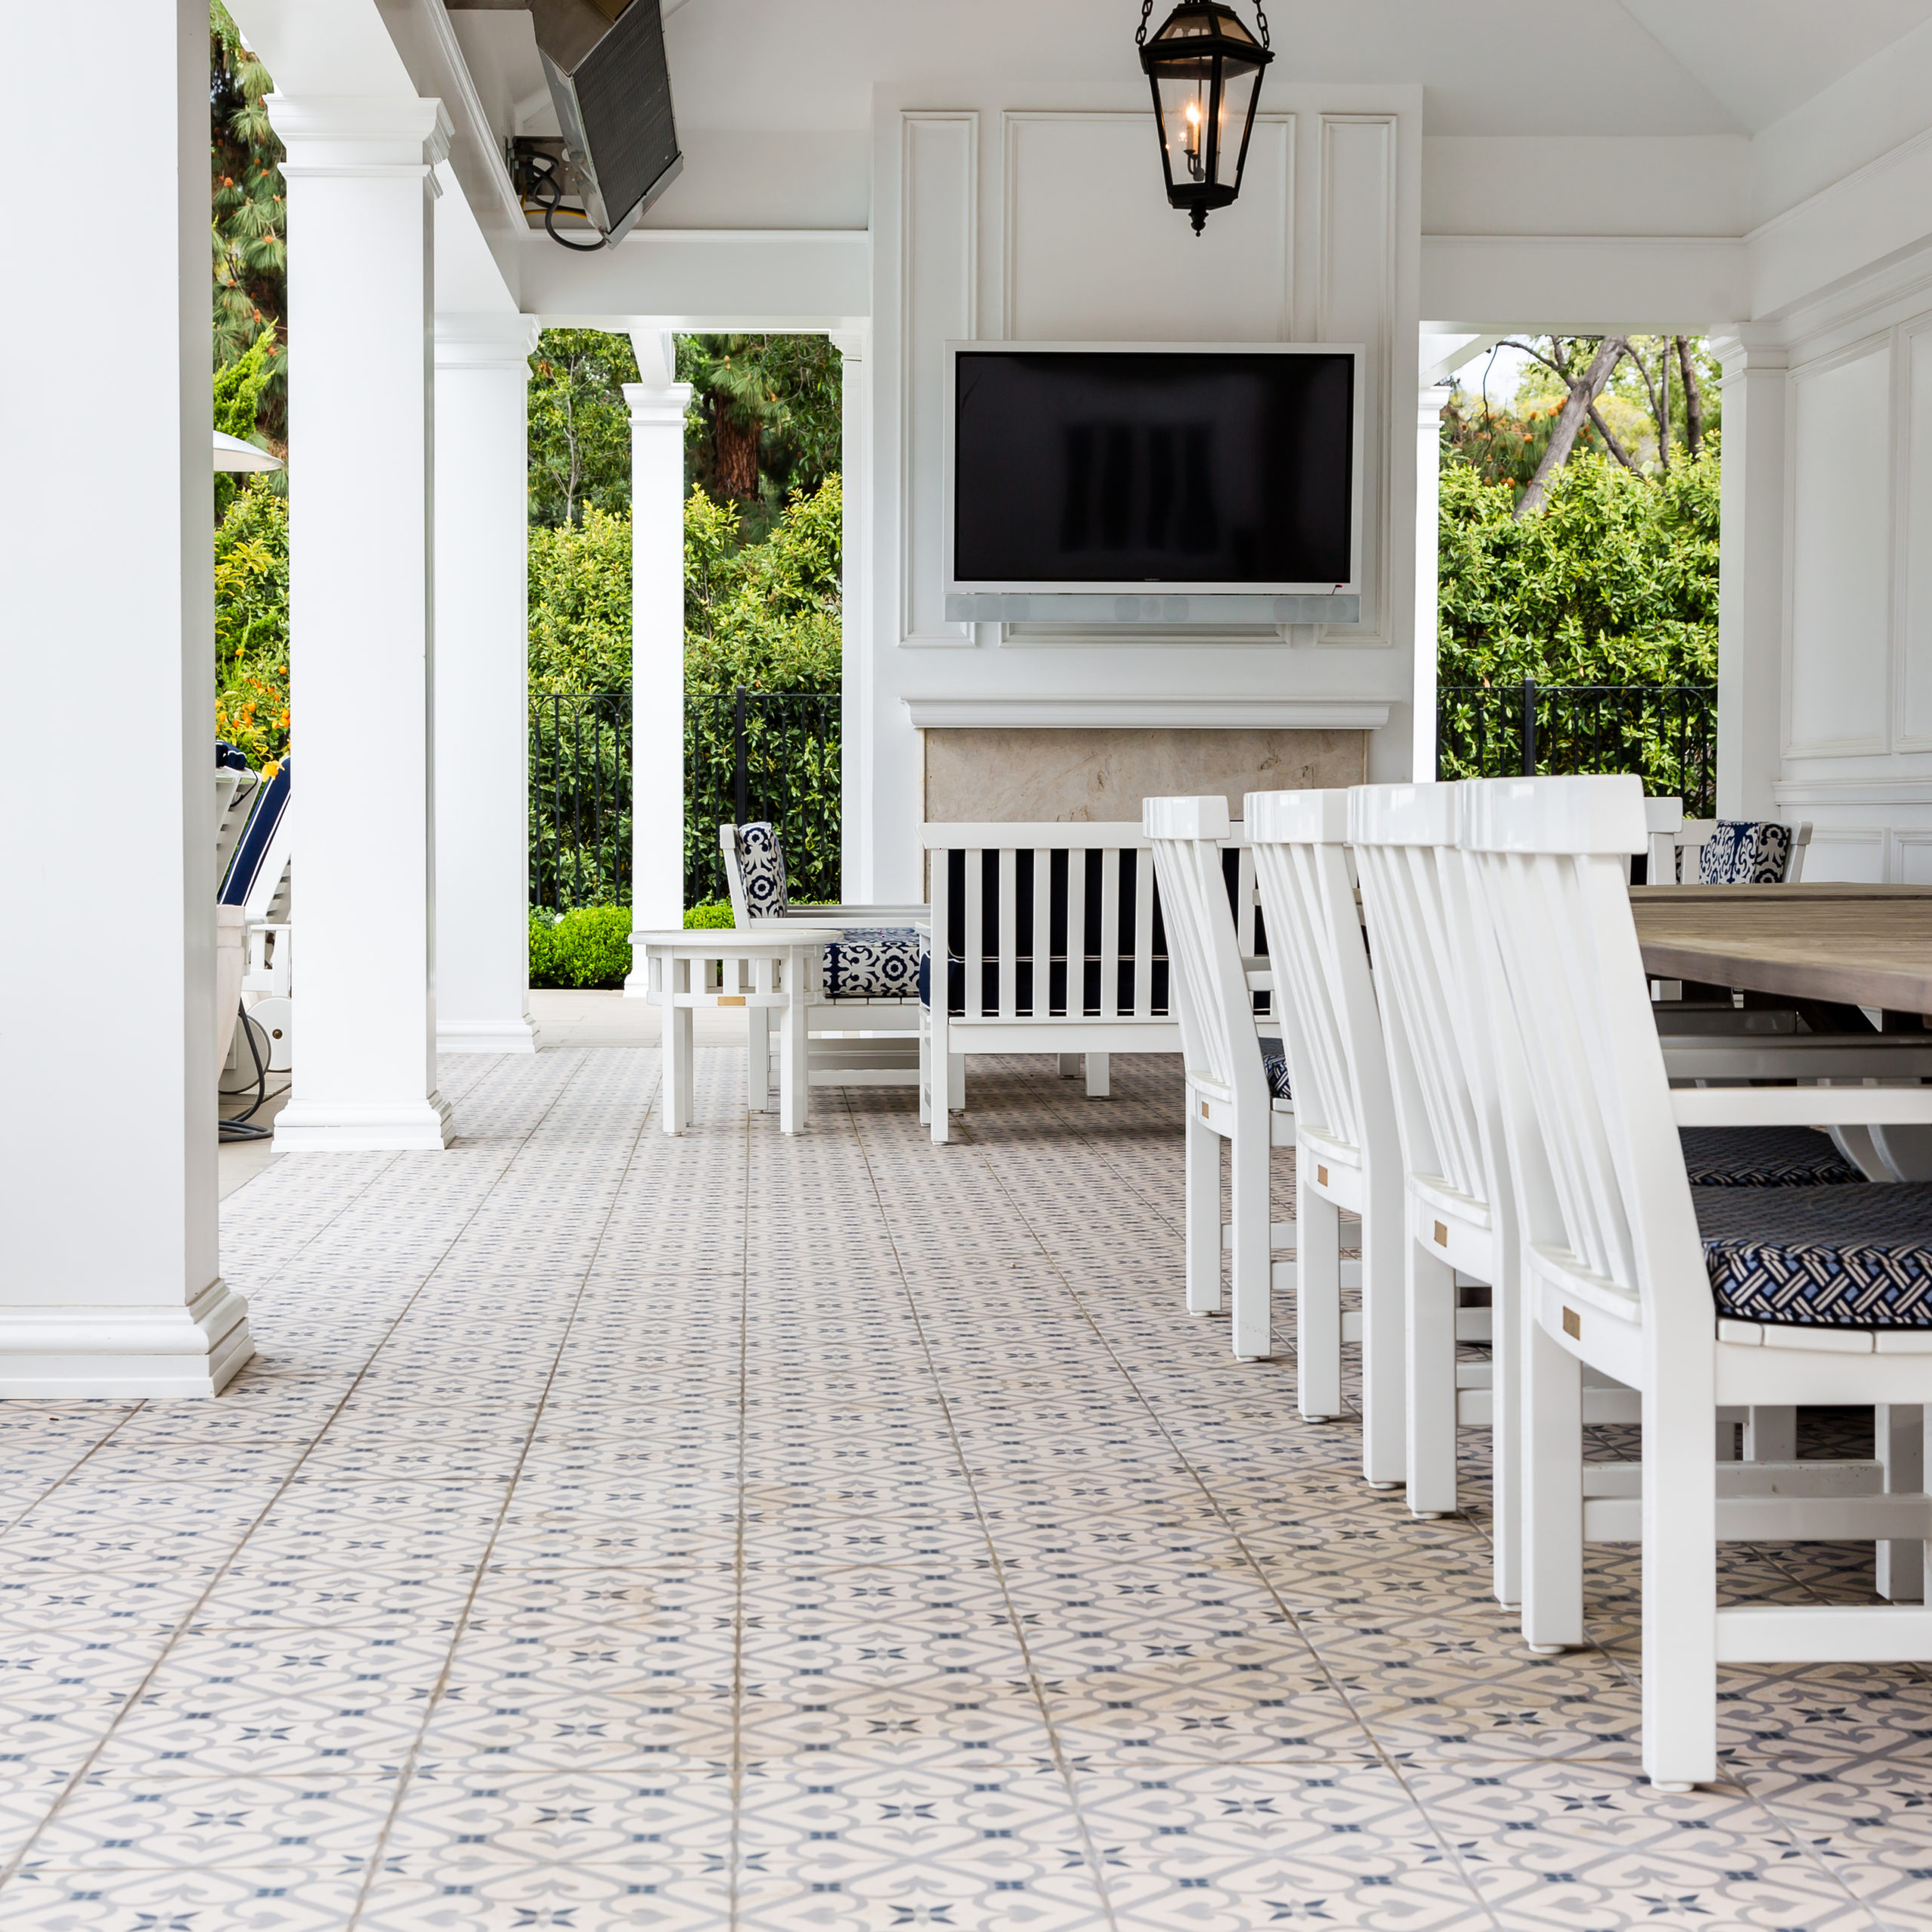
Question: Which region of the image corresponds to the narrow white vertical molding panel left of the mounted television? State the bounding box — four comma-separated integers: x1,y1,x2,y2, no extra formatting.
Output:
897,108,980,649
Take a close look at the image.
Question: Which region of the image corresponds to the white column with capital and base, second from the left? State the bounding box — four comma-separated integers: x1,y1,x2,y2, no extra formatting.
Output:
269,94,450,1152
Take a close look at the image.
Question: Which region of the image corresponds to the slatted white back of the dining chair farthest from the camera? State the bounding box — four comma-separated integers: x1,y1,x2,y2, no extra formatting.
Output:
1140,798,1267,1105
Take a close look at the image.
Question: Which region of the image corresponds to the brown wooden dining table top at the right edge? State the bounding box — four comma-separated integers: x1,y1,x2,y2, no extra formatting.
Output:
1631,884,1932,1032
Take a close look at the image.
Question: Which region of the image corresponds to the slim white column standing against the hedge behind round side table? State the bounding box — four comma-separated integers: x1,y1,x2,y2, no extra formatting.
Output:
624,331,691,966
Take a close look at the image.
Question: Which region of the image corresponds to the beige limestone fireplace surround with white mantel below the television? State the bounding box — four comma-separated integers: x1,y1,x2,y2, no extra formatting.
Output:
908,697,1389,825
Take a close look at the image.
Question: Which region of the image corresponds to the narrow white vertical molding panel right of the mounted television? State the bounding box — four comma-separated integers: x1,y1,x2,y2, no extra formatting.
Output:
1314,114,1414,648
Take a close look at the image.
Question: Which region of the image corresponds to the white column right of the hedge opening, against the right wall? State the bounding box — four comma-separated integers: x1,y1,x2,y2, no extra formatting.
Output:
1712,331,1787,819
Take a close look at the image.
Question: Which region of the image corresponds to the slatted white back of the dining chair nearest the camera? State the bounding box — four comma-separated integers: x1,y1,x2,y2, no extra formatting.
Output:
1460,777,1710,1335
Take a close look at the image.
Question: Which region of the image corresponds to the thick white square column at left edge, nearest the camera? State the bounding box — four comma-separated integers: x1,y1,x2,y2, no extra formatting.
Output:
0,0,253,1397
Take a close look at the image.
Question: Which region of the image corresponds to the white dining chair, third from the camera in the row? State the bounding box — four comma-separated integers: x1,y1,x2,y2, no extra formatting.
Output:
1242,790,1407,1490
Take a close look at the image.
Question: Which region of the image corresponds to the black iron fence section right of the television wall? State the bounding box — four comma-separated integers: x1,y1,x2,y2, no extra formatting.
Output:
1435,678,1718,819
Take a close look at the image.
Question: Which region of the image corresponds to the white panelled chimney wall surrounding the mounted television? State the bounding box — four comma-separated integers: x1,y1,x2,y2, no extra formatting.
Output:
848,82,1422,898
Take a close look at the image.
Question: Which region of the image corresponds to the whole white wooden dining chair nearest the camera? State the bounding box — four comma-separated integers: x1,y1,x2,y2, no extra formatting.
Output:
1463,777,1932,1789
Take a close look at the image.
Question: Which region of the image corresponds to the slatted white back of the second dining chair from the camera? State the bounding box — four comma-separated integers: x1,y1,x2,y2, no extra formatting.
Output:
1349,784,1500,1204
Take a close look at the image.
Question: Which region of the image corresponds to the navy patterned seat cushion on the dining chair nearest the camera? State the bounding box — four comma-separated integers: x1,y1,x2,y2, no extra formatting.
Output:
1690,1184,1932,1329
